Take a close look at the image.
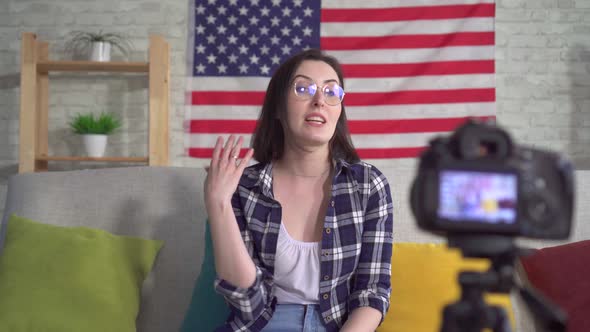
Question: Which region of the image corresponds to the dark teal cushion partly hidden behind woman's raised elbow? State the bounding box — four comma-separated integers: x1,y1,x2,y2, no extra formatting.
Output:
181,222,230,332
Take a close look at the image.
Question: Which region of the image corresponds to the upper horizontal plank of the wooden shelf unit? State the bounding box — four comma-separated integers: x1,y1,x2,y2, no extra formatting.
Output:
37,60,149,73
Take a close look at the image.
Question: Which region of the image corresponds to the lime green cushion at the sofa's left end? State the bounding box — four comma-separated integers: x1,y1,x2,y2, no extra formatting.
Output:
0,215,163,332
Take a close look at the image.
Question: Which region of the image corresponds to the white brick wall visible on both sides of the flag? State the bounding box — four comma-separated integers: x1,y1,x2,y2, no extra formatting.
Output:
0,0,590,215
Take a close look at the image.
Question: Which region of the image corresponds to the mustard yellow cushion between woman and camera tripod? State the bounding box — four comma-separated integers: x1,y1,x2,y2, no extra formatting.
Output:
377,243,515,332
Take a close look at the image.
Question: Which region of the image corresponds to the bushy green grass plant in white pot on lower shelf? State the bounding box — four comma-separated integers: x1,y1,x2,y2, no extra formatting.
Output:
69,113,121,158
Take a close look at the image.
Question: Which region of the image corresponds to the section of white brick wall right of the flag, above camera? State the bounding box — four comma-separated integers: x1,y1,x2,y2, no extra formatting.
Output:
496,0,590,169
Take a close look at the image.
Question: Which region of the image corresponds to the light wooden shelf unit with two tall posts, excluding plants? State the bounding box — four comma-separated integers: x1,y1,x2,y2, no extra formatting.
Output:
18,32,170,173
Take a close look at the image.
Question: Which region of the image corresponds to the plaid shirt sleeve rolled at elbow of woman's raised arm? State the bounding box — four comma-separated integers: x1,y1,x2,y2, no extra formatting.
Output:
214,188,273,325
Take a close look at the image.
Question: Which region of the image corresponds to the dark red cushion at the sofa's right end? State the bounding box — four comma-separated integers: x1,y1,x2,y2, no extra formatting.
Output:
520,240,590,332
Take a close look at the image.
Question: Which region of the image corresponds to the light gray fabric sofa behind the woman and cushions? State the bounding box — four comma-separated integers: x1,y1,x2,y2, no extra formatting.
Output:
0,167,590,332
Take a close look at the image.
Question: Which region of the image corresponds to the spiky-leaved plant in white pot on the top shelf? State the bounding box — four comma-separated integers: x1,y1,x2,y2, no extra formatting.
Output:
65,30,133,61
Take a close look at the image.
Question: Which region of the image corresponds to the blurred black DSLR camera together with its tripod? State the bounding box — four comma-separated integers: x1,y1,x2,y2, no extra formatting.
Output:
410,120,574,332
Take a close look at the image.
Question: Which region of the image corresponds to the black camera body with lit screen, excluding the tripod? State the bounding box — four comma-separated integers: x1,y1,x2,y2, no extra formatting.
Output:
410,119,574,239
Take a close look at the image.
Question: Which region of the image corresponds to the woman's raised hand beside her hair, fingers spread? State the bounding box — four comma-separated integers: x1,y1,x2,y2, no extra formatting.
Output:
205,135,254,213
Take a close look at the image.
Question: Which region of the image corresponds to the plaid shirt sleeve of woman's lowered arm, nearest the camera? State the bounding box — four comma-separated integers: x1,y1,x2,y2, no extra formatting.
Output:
348,168,393,321
